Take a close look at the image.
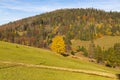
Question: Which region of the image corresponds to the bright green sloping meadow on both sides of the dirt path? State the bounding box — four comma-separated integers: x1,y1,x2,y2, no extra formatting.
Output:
0,41,120,80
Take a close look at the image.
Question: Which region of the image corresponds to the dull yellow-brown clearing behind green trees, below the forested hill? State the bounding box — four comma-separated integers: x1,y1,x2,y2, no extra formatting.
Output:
72,36,120,50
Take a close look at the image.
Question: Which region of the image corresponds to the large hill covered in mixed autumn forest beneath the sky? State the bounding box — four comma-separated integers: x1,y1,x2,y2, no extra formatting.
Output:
0,9,120,48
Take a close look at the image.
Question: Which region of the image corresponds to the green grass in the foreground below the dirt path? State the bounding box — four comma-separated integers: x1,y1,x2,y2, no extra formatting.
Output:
0,66,115,80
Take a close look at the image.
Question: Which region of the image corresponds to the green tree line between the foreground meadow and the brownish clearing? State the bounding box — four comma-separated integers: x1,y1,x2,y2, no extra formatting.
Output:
75,42,120,68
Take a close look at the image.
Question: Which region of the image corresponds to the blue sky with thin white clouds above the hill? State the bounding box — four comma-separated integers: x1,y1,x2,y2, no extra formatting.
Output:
0,0,120,25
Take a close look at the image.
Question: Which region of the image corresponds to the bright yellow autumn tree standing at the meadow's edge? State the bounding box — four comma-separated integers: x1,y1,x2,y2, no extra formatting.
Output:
50,36,66,54
